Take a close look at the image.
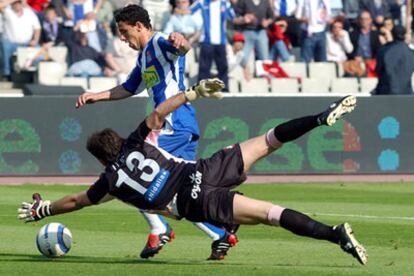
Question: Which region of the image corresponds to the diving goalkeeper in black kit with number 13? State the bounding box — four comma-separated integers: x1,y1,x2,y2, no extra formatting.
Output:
18,79,367,264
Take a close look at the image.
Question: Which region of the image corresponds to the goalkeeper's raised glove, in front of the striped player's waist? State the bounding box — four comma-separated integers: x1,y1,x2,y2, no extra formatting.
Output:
184,78,224,102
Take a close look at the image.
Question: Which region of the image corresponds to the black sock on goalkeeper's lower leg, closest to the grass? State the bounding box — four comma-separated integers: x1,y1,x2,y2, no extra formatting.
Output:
280,209,339,243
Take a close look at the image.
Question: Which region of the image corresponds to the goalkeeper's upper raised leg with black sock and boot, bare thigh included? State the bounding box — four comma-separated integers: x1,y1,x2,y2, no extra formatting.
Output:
240,96,356,172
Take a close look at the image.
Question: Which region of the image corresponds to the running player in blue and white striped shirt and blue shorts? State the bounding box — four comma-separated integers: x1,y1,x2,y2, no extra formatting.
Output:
76,5,237,260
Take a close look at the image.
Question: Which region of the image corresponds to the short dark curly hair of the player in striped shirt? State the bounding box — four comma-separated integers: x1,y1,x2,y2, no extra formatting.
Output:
115,5,152,29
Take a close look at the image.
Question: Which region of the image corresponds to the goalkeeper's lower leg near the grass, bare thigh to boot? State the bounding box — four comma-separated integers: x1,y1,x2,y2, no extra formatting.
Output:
233,194,367,264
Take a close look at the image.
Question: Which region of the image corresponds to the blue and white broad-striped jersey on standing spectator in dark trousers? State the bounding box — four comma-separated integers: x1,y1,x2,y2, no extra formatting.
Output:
191,0,236,45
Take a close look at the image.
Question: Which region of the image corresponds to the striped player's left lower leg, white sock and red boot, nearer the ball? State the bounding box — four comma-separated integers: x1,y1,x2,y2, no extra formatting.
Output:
140,210,175,259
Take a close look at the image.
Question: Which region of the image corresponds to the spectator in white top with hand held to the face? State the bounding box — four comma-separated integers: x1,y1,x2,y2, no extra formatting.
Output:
326,17,354,63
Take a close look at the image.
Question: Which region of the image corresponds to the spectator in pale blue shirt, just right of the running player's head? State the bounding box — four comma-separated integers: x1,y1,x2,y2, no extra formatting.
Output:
164,0,201,44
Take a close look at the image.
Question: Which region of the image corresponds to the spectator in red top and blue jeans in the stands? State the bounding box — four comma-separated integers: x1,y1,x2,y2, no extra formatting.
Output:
267,20,290,62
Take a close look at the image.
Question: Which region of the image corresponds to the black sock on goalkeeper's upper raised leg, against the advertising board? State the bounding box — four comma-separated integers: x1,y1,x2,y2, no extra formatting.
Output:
274,114,320,143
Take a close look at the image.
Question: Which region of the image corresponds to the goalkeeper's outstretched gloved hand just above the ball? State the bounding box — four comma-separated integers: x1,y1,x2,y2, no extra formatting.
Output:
17,193,51,222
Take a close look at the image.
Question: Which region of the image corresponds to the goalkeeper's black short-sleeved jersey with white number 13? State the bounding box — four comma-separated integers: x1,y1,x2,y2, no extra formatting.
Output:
87,121,195,209
